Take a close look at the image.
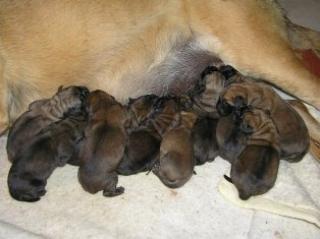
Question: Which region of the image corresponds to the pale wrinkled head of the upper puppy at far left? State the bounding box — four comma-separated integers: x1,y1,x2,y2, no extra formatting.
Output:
47,86,89,118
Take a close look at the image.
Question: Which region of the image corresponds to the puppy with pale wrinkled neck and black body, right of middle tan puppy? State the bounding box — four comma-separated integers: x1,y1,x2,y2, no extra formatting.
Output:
188,66,234,165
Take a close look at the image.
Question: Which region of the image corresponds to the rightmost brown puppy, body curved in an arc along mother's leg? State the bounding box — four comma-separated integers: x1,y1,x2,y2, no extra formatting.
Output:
217,68,310,162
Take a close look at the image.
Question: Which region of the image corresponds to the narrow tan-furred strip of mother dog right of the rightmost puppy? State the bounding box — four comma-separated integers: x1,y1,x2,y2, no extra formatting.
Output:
288,100,320,162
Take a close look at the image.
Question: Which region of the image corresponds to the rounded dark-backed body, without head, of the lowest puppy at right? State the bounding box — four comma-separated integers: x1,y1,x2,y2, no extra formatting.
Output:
231,145,279,200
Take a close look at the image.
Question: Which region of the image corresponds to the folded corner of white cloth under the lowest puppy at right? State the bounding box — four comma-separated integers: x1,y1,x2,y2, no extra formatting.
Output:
219,154,320,228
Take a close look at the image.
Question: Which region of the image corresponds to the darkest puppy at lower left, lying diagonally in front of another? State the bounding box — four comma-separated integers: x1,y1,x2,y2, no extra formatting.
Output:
8,112,86,202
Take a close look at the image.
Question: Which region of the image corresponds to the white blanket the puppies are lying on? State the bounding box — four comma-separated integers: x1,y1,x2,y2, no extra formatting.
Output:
0,134,320,239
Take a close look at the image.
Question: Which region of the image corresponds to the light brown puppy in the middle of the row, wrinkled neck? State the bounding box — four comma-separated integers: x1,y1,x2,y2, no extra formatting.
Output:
152,96,197,188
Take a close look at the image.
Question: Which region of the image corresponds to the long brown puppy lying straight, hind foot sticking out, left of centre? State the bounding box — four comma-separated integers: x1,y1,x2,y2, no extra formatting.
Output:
78,90,127,197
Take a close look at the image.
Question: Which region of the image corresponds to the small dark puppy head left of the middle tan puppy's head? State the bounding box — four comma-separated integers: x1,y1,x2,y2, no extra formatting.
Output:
127,94,159,125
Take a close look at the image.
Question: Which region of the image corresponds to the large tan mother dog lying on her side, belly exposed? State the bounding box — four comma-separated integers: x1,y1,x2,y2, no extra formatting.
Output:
0,0,320,131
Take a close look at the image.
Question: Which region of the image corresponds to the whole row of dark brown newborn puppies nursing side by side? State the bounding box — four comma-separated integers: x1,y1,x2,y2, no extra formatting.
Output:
7,65,310,202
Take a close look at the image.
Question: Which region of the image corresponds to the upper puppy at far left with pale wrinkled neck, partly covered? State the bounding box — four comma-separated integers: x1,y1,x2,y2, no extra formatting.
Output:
7,86,89,162
